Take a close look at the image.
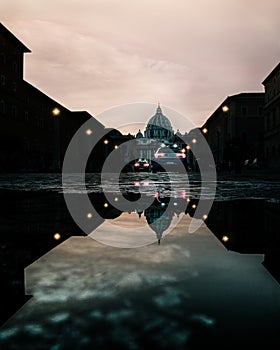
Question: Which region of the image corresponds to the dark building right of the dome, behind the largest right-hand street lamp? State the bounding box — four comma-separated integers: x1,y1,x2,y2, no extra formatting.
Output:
200,92,264,170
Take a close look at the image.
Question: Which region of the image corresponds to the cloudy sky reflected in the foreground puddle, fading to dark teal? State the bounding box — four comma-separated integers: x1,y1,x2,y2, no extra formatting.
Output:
0,196,280,350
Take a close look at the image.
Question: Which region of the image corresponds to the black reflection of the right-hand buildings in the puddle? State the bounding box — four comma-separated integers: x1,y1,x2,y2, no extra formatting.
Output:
205,199,280,283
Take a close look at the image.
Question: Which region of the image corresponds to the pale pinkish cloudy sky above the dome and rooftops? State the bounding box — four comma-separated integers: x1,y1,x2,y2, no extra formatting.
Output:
0,0,280,131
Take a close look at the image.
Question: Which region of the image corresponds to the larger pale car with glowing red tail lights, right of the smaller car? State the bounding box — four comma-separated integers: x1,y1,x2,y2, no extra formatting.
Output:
152,145,187,172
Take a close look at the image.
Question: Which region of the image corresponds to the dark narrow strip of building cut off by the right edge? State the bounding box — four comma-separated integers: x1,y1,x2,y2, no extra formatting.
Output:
262,63,280,168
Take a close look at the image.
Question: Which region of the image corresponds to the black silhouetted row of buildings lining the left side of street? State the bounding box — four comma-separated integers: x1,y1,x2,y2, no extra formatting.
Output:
0,24,124,172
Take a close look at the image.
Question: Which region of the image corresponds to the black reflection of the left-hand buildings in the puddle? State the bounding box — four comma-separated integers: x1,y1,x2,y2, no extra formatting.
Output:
0,191,88,324
